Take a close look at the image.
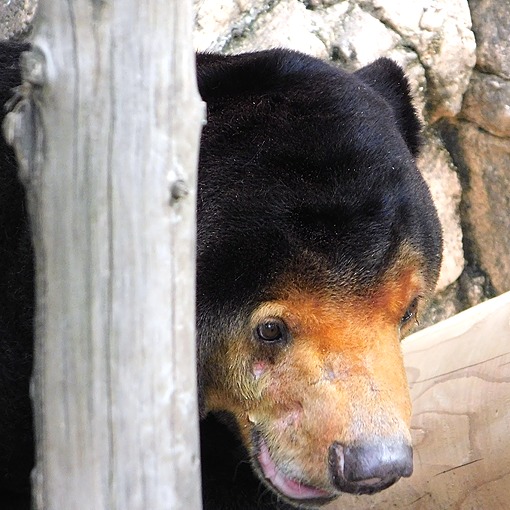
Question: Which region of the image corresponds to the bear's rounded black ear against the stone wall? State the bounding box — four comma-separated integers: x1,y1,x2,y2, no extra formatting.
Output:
354,58,422,157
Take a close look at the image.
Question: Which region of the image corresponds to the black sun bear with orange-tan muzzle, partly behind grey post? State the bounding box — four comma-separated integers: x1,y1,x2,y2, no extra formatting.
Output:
0,44,442,510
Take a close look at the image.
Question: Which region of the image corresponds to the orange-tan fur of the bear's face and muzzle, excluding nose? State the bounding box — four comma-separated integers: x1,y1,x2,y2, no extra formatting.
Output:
206,258,424,490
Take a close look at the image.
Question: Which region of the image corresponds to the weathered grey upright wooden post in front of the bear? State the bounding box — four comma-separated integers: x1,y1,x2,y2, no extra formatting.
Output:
4,0,203,510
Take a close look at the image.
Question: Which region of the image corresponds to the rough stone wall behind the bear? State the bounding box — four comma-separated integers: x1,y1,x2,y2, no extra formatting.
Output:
0,0,510,325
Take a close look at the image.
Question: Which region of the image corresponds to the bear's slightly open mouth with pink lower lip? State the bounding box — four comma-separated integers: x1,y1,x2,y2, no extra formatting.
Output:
253,432,337,505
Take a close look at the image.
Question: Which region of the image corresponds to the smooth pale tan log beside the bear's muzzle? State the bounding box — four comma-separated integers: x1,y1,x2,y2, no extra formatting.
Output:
328,293,510,510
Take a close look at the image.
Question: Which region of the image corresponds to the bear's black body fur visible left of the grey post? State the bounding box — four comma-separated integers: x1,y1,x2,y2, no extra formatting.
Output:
0,43,34,510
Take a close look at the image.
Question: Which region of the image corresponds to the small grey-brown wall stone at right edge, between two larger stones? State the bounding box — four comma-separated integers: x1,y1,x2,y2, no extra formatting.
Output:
461,71,510,137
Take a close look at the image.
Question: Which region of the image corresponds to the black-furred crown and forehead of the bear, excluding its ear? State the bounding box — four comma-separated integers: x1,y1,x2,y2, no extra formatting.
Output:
197,51,438,318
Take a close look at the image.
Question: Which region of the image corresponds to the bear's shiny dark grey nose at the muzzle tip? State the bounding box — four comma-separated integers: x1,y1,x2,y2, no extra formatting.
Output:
329,438,413,494
